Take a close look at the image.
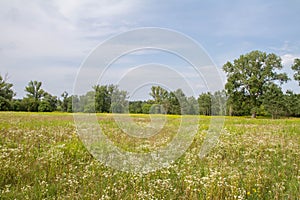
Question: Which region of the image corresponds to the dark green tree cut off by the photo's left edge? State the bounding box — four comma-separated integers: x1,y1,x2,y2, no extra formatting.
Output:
0,75,15,111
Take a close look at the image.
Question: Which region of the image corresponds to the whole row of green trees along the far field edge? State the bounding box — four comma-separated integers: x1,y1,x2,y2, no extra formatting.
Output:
0,51,300,118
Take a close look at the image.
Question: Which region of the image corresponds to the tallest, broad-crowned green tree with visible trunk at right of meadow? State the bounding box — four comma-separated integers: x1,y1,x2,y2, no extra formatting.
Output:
223,51,288,118
